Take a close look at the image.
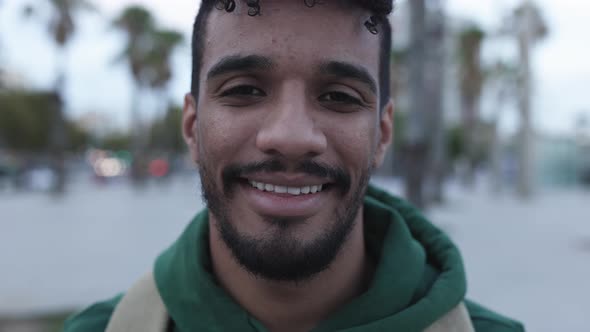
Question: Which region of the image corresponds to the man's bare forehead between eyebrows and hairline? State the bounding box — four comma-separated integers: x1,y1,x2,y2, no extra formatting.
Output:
201,0,380,77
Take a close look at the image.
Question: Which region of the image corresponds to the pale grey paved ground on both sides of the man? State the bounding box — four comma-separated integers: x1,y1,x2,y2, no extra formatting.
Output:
0,178,590,332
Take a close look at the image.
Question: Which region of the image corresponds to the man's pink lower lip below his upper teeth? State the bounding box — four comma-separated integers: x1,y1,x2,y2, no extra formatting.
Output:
241,184,330,218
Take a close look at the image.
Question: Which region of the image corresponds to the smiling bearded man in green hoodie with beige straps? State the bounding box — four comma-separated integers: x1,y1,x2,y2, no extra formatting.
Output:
65,0,523,332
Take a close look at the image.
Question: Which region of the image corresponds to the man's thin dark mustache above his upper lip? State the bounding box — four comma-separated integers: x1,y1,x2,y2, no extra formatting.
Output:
222,159,351,193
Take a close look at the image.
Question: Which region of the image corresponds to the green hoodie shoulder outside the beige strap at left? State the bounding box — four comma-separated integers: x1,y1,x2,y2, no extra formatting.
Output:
63,294,123,332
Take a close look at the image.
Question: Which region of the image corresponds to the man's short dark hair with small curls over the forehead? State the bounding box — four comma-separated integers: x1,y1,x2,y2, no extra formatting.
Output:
191,0,393,110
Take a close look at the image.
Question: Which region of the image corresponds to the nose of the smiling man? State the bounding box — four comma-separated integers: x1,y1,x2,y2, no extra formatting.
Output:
256,85,327,161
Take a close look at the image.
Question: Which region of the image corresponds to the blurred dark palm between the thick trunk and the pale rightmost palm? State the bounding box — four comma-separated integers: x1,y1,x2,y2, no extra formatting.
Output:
458,24,485,187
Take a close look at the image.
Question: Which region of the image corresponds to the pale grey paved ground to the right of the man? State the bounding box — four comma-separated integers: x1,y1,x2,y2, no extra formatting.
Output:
431,182,590,332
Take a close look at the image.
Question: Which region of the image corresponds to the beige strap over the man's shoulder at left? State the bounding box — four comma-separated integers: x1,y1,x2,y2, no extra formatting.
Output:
106,273,168,332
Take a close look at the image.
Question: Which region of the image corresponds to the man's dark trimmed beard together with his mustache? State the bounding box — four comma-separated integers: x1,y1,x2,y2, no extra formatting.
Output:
199,159,371,283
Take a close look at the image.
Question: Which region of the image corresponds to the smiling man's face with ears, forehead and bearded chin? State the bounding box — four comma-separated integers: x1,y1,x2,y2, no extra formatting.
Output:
183,0,392,281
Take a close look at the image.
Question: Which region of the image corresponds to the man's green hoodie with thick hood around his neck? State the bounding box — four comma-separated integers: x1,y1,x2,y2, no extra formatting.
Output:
64,186,524,332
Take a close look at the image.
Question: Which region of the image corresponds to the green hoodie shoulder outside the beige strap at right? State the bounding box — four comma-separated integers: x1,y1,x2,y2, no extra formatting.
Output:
465,300,524,332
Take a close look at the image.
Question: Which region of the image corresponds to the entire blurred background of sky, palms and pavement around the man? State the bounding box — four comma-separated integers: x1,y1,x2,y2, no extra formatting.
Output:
0,0,590,332
